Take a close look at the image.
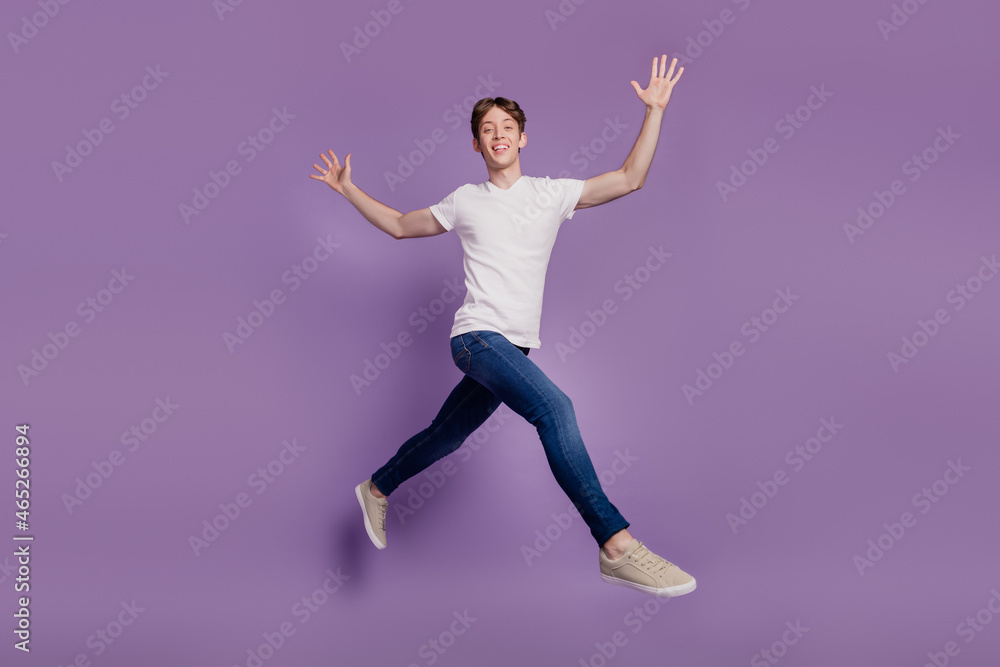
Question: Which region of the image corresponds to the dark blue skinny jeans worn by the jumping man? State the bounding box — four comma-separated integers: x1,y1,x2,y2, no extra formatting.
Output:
372,331,629,545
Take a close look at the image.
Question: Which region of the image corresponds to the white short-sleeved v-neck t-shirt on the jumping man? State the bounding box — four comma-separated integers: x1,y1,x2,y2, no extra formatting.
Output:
430,174,583,348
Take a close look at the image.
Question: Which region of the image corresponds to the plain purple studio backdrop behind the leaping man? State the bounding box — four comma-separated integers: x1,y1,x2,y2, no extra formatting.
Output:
0,0,1000,667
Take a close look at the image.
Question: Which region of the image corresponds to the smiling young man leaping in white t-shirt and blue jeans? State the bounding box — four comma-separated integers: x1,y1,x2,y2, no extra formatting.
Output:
310,55,695,596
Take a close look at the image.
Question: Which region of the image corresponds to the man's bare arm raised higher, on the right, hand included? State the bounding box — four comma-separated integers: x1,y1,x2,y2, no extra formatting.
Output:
576,55,684,209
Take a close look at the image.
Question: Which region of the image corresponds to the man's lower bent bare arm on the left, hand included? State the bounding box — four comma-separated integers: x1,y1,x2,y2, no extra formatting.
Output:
309,150,448,239
